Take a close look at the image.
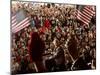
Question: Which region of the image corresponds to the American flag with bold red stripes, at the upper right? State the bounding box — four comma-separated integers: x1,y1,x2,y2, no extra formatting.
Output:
75,5,95,25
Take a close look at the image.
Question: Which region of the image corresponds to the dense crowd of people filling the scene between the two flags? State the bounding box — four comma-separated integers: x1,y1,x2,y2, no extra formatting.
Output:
11,2,96,73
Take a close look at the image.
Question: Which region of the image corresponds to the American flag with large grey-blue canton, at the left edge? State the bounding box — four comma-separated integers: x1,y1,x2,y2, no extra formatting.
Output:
11,10,30,33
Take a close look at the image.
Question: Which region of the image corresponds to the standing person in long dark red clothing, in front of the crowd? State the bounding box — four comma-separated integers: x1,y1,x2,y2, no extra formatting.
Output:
28,32,46,72
